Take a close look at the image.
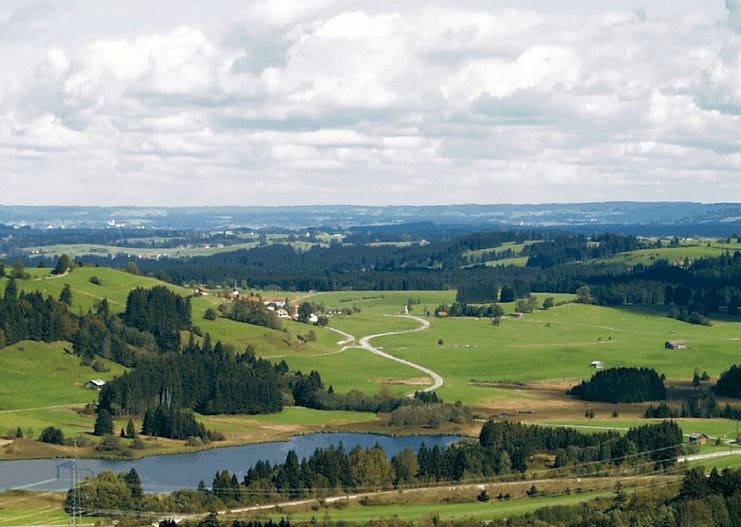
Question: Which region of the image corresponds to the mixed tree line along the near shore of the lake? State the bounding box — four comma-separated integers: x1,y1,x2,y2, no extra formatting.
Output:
68,421,682,515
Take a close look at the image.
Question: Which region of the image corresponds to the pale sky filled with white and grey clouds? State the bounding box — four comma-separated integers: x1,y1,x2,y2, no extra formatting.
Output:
0,0,741,206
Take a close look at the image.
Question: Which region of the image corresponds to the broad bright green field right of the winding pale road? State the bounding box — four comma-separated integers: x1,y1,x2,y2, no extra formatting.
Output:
368,304,741,403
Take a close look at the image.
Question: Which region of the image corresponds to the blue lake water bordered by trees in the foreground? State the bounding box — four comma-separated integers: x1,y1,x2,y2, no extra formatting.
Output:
0,433,459,492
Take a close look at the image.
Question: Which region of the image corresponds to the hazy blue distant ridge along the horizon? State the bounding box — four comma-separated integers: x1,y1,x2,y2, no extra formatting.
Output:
0,201,741,232
